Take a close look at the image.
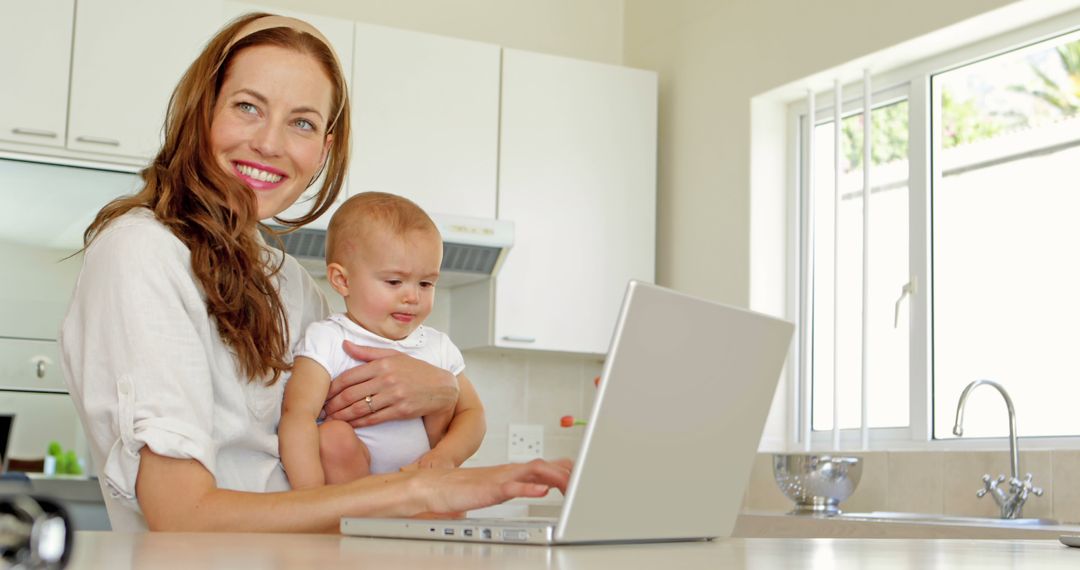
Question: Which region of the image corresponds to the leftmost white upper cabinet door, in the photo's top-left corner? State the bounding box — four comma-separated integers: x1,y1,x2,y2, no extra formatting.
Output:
0,0,75,147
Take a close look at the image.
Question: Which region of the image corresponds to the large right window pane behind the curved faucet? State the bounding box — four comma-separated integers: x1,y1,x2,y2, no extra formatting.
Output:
931,35,1080,438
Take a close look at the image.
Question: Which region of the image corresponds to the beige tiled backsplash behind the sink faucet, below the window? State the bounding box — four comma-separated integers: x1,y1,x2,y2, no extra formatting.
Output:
743,450,1080,524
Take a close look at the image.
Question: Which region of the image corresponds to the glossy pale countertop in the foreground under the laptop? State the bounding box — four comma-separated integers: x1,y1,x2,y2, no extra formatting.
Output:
68,531,1080,570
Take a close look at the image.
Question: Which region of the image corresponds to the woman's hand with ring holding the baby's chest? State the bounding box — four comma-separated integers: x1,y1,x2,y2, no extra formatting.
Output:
323,341,458,428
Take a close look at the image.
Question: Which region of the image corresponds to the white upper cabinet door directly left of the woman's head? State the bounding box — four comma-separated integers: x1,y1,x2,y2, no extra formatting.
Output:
67,0,221,159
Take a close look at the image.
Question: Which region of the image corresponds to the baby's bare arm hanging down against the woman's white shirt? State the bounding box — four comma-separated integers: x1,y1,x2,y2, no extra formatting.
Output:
278,356,330,489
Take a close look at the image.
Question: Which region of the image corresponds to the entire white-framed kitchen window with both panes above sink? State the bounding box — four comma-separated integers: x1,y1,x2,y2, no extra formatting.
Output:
789,14,1080,447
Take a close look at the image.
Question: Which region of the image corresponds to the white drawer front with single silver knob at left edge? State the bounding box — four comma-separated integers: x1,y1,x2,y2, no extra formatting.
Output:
0,338,67,393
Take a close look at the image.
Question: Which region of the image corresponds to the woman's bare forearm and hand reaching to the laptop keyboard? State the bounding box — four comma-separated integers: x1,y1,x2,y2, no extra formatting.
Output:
135,447,570,532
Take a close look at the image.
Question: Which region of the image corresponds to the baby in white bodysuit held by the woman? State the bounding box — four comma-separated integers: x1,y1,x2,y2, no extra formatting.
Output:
278,192,485,489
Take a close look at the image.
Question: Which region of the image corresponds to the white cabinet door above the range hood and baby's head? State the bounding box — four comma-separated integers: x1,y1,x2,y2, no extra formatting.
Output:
350,24,499,218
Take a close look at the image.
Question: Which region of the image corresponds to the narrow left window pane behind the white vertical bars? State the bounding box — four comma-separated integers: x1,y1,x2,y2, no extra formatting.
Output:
811,99,908,430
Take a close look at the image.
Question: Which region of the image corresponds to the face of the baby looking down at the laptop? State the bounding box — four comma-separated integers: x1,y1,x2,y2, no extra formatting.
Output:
342,226,443,340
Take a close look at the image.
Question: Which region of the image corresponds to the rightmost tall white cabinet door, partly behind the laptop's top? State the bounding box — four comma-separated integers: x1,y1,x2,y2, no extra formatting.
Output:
494,50,657,353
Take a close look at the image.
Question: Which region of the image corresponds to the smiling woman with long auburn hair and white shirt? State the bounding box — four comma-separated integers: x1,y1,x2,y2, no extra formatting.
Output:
60,14,569,531
